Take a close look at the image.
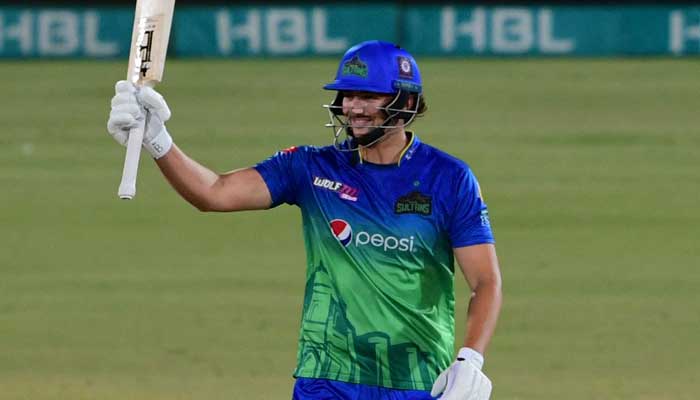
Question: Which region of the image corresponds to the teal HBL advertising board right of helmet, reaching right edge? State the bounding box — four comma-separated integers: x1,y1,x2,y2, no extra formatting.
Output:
403,6,700,56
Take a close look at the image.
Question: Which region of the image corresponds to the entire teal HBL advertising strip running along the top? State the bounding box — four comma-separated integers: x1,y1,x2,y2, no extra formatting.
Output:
0,3,700,58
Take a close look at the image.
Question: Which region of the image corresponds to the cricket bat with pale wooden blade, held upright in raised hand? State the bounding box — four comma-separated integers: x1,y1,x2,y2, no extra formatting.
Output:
118,0,175,200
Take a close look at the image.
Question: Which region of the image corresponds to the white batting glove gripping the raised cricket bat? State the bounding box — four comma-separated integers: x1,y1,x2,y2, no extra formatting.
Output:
107,81,173,159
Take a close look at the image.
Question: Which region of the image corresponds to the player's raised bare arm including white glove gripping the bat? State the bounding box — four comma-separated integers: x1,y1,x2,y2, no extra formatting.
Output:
107,81,272,211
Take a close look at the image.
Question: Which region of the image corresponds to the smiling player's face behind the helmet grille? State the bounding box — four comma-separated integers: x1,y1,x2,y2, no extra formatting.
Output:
343,92,394,136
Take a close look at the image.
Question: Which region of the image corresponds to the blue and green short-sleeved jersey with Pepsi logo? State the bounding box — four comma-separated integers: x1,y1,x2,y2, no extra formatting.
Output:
255,134,494,390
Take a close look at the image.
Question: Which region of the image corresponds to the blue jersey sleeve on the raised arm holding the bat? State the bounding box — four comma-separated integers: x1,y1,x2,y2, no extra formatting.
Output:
254,147,304,208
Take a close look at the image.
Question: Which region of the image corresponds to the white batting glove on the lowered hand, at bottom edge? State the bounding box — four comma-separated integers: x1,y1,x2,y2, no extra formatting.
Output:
430,347,491,400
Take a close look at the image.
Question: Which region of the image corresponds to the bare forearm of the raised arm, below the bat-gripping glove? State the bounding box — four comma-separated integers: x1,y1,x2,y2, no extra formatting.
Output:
156,144,219,211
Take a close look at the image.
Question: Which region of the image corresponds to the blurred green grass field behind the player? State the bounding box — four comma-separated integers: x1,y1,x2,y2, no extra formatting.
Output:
0,59,700,400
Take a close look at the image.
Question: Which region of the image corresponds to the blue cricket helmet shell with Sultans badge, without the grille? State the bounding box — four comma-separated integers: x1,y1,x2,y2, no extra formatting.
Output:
323,40,423,94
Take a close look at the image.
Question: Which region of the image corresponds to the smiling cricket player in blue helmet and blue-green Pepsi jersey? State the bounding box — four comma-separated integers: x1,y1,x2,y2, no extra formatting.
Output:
108,41,501,400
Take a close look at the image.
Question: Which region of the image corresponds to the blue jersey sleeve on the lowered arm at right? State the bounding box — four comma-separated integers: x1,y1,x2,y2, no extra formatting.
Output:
448,166,495,248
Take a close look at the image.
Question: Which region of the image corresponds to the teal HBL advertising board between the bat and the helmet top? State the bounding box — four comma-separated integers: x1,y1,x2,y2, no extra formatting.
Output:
178,4,399,57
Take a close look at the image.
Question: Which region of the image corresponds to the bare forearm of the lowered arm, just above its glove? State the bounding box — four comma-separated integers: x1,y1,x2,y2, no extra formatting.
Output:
464,276,502,354
